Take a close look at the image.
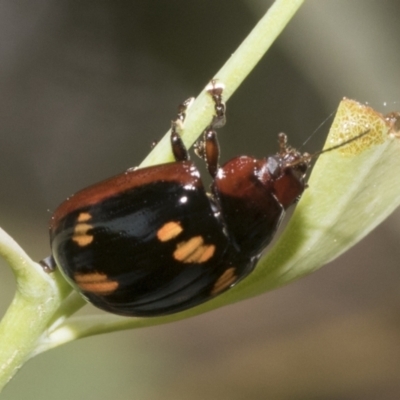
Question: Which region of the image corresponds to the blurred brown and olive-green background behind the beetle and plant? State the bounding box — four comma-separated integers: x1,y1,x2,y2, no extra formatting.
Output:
0,0,400,400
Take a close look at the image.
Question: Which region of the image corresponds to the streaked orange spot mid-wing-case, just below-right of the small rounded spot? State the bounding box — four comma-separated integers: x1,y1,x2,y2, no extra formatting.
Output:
174,236,215,263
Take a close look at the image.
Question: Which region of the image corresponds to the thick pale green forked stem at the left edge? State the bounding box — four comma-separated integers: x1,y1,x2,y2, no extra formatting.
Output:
0,229,70,390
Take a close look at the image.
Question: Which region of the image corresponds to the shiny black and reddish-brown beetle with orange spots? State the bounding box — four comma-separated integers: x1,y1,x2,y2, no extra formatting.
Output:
50,81,309,317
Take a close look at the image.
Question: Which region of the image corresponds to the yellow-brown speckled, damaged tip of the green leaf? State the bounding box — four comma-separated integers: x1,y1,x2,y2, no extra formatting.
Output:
326,98,390,155
